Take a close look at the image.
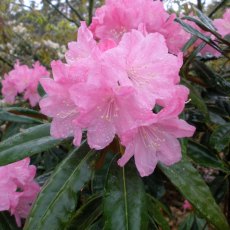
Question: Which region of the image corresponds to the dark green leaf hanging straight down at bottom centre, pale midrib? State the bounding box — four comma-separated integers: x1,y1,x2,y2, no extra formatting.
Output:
104,160,148,230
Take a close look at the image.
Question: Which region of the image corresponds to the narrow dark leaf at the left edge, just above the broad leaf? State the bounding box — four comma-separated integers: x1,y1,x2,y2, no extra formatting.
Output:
0,111,43,124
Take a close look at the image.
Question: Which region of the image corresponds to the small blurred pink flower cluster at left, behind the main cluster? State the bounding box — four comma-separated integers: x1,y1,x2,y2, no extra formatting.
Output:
2,62,49,106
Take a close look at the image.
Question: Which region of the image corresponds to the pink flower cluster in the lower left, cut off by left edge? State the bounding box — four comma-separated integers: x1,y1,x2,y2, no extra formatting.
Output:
0,158,40,226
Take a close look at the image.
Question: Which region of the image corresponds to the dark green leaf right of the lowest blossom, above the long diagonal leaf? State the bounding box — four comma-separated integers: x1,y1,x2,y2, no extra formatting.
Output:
187,140,228,172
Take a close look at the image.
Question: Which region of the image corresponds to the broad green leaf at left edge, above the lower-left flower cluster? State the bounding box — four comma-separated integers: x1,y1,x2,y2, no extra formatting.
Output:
0,124,63,165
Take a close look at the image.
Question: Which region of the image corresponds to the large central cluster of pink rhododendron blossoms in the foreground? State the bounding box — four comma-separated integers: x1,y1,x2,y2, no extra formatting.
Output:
40,0,195,176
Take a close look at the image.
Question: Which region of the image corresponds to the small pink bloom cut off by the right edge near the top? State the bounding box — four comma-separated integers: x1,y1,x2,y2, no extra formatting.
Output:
213,9,230,37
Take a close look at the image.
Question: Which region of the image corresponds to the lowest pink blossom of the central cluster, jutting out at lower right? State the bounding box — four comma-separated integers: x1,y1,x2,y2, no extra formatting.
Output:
118,93,195,176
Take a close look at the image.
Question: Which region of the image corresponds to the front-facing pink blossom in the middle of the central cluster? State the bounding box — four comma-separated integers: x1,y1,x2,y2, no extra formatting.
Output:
70,84,151,149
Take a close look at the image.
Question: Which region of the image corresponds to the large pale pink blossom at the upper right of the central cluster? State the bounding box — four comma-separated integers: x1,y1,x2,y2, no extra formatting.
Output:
99,30,182,110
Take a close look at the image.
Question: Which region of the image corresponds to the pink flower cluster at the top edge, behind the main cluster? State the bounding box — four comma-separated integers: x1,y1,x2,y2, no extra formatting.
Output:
90,0,189,54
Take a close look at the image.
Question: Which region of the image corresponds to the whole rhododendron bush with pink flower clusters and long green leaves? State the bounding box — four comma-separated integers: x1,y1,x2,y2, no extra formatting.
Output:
0,0,230,230
